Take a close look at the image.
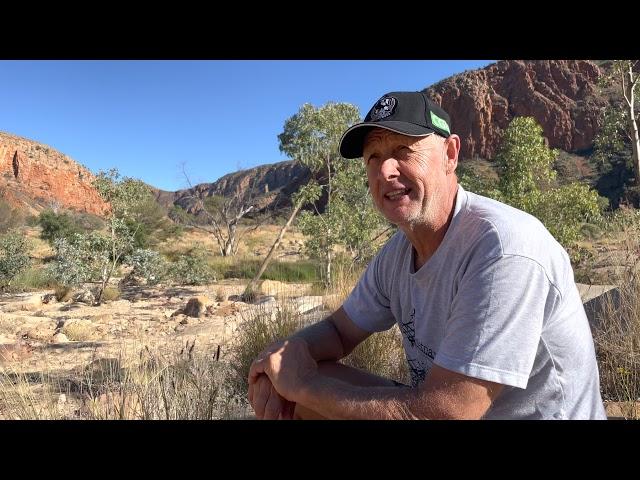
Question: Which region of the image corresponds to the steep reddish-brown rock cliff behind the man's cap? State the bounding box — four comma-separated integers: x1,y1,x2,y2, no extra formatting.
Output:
423,60,605,159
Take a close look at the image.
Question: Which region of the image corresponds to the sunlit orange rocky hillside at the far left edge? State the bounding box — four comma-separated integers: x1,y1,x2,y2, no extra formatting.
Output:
0,132,106,215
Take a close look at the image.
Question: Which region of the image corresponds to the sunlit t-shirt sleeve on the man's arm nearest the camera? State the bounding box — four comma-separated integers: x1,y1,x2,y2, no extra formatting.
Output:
434,255,556,388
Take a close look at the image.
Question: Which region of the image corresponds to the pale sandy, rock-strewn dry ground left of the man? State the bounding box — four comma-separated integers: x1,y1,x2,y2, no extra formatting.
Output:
0,280,323,418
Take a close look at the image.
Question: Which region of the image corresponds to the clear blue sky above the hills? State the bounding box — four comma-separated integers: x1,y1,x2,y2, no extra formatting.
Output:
0,60,493,190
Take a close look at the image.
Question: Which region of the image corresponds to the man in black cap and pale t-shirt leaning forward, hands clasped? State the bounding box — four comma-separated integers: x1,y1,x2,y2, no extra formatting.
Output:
249,92,606,419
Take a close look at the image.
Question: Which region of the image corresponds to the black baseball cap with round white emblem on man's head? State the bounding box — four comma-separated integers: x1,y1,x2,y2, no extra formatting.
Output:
340,92,451,158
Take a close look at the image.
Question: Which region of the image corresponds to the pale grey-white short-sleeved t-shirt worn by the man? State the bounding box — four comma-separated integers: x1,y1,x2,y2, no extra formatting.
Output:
344,186,606,419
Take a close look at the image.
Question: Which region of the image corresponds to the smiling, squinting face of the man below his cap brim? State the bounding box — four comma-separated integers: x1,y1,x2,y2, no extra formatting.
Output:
363,128,452,228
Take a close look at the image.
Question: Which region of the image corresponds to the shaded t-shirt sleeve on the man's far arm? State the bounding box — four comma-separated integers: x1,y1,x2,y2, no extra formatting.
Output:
342,251,396,332
